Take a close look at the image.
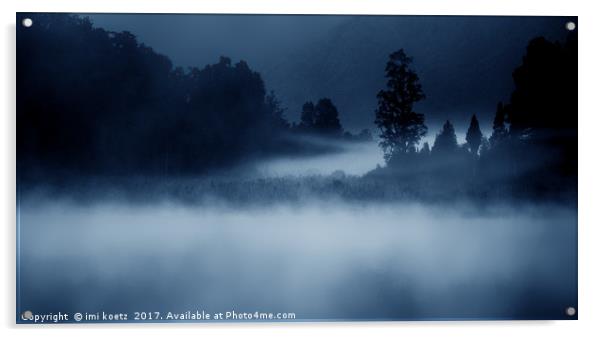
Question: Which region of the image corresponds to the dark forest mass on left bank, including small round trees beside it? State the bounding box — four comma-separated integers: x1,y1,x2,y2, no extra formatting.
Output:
17,14,366,176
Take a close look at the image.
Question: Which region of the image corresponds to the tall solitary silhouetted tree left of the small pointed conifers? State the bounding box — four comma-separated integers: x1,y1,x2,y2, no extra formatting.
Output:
375,49,427,162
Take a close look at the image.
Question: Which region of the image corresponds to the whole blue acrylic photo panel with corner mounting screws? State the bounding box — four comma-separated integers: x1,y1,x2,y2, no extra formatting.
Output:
16,13,578,323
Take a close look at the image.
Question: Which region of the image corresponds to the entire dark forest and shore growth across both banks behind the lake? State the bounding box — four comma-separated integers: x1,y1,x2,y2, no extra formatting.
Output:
17,14,577,199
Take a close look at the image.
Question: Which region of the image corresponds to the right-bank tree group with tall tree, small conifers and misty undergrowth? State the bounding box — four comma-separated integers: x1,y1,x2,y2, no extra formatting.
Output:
375,32,577,197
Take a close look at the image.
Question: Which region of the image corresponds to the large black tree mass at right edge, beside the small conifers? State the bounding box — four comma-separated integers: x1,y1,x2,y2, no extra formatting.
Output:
500,31,578,176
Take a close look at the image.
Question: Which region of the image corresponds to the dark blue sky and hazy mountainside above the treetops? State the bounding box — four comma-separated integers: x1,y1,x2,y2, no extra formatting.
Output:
89,14,576,140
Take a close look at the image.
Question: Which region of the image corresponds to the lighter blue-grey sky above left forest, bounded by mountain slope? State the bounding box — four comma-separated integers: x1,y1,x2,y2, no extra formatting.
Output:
89,14,345,68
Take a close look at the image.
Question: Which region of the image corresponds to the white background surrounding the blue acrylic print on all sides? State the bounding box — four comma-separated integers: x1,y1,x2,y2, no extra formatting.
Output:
0,0,602,337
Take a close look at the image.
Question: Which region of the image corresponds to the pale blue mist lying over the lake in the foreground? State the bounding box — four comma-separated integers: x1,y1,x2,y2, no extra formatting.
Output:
19,200,577,319
